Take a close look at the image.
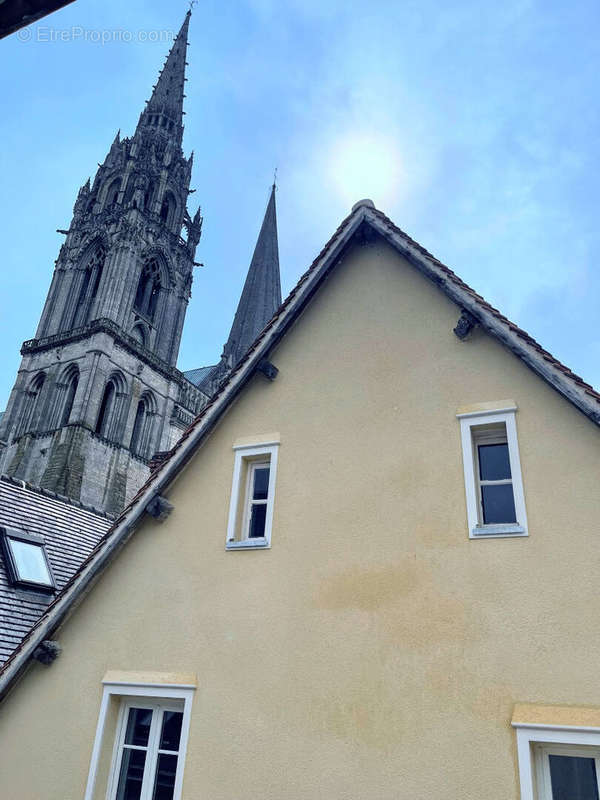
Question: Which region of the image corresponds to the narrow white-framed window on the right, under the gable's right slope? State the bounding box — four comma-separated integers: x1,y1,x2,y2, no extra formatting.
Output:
457,406,527,538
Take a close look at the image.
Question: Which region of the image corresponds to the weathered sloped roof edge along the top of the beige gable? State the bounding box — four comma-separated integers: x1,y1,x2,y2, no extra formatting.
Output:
0,204,600,698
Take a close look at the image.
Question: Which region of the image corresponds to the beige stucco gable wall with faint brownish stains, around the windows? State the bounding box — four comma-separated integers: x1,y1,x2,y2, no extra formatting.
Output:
0,243,600,800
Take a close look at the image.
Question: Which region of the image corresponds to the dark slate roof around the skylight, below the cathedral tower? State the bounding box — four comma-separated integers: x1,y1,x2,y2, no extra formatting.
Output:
0,476,111,667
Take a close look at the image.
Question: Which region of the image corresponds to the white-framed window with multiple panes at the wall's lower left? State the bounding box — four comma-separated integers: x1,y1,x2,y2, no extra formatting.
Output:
85,680,195,800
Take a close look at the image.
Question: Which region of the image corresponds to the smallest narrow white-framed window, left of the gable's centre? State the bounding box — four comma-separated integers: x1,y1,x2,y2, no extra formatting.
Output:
226,442,279,550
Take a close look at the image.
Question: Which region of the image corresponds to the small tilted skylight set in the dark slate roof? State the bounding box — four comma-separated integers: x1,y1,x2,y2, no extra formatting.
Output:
0,528,54,591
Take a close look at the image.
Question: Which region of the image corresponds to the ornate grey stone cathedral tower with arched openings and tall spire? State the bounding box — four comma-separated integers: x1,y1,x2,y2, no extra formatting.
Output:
0,12,207,512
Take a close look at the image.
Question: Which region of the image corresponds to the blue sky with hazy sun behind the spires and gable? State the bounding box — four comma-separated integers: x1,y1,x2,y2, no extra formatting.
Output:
0,0,600,408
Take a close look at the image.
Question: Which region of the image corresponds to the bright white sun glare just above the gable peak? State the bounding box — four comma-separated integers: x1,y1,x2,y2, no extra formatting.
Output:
329,134,401,207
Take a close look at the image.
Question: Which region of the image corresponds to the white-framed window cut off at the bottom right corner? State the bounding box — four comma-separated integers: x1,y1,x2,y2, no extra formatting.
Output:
513,723,600,800
